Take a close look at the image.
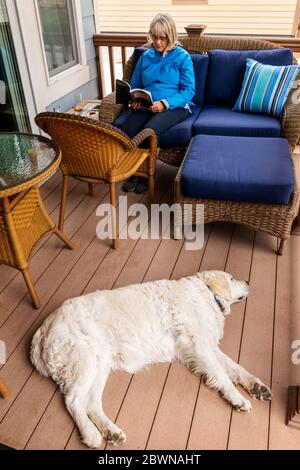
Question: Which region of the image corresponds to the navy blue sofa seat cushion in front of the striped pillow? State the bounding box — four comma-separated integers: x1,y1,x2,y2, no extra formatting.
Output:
193,105,281,137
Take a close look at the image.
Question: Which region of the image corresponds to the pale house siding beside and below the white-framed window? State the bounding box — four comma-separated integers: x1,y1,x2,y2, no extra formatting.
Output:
47,0,99,111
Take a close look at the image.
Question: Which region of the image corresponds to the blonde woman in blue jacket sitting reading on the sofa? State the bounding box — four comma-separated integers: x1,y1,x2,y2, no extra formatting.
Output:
119,13,195,193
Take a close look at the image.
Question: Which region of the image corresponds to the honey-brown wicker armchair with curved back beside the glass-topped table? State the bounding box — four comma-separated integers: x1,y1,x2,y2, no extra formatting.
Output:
35,112,157,248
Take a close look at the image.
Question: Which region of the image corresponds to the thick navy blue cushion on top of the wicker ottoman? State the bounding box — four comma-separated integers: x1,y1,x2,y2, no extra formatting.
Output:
182,135,294,204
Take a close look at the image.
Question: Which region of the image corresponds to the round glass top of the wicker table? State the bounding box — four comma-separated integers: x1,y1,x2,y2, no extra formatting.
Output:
0,132,59,191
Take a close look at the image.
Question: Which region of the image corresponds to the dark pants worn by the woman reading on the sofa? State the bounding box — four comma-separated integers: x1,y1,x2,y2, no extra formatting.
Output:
118,108,190,147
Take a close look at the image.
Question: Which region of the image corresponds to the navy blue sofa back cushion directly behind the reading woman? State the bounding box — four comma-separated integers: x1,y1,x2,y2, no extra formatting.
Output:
132,47,208,106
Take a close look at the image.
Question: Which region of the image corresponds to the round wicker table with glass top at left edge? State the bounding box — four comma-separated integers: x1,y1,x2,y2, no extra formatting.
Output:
0,133,73,308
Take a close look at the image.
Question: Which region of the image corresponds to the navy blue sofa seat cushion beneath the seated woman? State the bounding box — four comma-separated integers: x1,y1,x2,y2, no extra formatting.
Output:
114,106,202,148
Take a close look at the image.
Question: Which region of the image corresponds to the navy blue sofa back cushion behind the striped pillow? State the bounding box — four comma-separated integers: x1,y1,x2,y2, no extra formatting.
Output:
205,48,293,107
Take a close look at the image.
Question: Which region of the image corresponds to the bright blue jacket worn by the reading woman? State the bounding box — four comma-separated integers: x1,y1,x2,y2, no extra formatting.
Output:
130,46,195,109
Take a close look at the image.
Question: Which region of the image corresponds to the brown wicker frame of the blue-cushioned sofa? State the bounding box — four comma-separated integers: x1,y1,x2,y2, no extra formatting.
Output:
99,35,300,166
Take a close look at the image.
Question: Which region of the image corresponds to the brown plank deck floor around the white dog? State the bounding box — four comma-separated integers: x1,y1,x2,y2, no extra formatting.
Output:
0,161,300,450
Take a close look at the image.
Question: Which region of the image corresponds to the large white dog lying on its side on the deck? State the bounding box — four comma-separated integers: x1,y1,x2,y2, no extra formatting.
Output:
31,271,272,448
